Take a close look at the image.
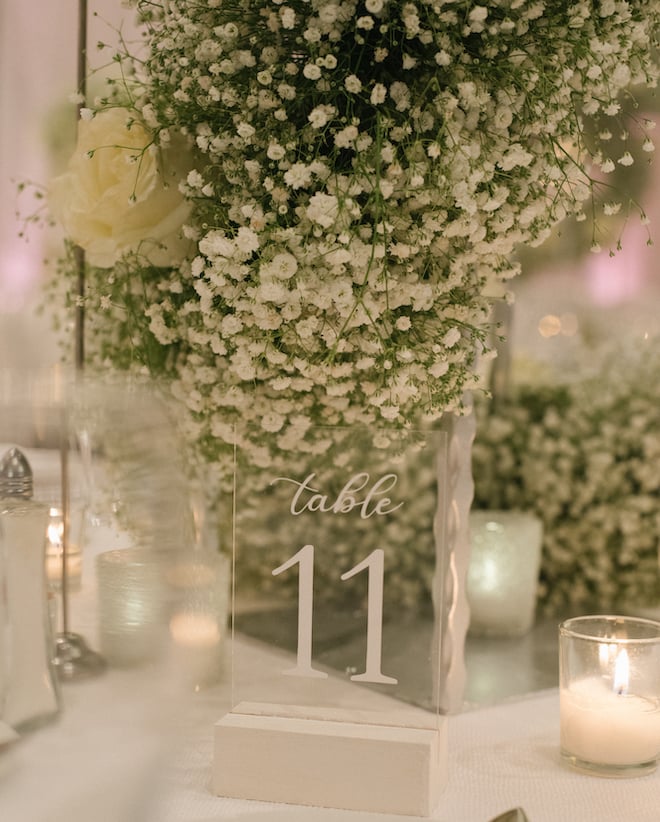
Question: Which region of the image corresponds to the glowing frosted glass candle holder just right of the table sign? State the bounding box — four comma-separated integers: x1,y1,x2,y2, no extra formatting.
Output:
467,510,543,637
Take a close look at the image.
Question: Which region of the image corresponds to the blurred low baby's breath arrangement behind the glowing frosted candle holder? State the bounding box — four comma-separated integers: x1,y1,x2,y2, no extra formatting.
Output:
473,339,660,613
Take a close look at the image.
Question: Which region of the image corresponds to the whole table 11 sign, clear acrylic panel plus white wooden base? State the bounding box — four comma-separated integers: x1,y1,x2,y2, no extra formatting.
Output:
214,428,458,816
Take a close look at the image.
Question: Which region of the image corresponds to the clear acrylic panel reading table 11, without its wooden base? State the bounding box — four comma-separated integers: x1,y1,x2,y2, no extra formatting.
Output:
232,428,448,728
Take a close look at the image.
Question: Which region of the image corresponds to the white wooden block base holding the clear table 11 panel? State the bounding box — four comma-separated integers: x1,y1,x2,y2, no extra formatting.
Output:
213,702,447,816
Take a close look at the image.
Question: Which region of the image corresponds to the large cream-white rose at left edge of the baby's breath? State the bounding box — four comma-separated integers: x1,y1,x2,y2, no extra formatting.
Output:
49,108,191,268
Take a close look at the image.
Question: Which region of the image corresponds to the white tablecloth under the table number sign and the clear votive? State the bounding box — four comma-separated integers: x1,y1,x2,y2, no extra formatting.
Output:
0,672,660,822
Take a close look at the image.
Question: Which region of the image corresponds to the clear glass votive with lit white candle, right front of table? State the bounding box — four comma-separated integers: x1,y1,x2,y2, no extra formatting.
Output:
559,616,660,777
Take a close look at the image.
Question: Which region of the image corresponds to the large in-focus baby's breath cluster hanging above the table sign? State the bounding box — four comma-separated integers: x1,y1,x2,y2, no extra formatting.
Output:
51,0,660,480
